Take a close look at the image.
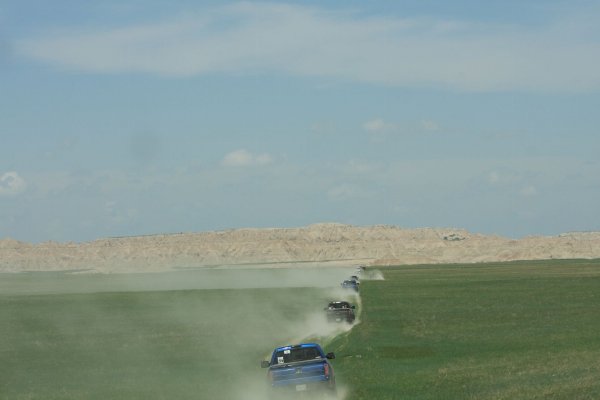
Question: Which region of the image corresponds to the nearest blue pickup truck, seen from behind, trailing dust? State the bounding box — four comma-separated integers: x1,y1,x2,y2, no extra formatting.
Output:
261,343,336,395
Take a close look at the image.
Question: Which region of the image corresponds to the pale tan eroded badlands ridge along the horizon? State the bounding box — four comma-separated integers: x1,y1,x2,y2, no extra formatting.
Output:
0,224,600,273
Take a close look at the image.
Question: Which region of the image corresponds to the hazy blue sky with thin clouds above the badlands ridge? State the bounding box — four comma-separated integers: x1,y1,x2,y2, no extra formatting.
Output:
0,0,600,242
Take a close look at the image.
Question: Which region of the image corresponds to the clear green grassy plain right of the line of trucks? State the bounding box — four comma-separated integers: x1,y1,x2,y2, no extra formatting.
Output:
331,260,600,400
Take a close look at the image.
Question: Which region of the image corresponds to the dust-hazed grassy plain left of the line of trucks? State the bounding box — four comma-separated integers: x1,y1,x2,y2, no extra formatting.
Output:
0,270,346,400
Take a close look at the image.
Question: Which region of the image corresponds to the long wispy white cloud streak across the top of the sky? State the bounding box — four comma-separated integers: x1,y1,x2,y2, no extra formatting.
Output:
15,2,600,91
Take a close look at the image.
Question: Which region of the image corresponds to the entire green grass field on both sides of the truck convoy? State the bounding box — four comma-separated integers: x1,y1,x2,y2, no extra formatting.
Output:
0,260,600,400
